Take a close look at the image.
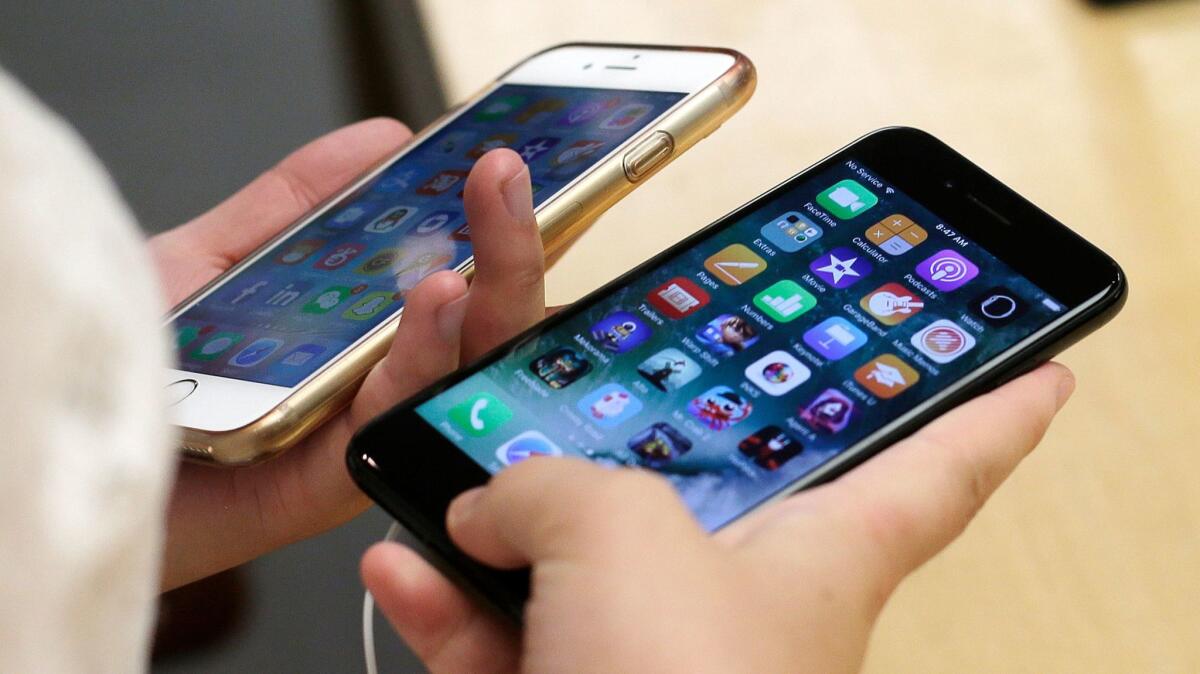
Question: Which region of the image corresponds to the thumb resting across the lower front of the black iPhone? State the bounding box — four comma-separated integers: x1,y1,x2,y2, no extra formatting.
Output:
446,457,706,568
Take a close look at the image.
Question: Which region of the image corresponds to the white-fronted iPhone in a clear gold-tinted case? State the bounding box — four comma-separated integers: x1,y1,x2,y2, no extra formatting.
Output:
166,44,755,464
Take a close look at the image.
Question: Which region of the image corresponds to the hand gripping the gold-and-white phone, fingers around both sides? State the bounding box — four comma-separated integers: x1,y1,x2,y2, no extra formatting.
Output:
150,119,545,589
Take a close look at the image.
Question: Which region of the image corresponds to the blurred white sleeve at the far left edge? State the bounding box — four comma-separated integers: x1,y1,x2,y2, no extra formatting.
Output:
0,71,174,673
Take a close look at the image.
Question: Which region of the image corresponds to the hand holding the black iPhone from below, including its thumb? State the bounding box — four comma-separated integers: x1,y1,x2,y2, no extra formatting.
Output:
362,363,1074,674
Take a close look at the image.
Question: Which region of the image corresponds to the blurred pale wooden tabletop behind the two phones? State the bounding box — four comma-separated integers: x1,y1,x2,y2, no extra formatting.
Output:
421,0,1200,673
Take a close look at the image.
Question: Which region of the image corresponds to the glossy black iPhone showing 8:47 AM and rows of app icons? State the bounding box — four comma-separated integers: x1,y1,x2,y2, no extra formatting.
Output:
347,128,1126,620
